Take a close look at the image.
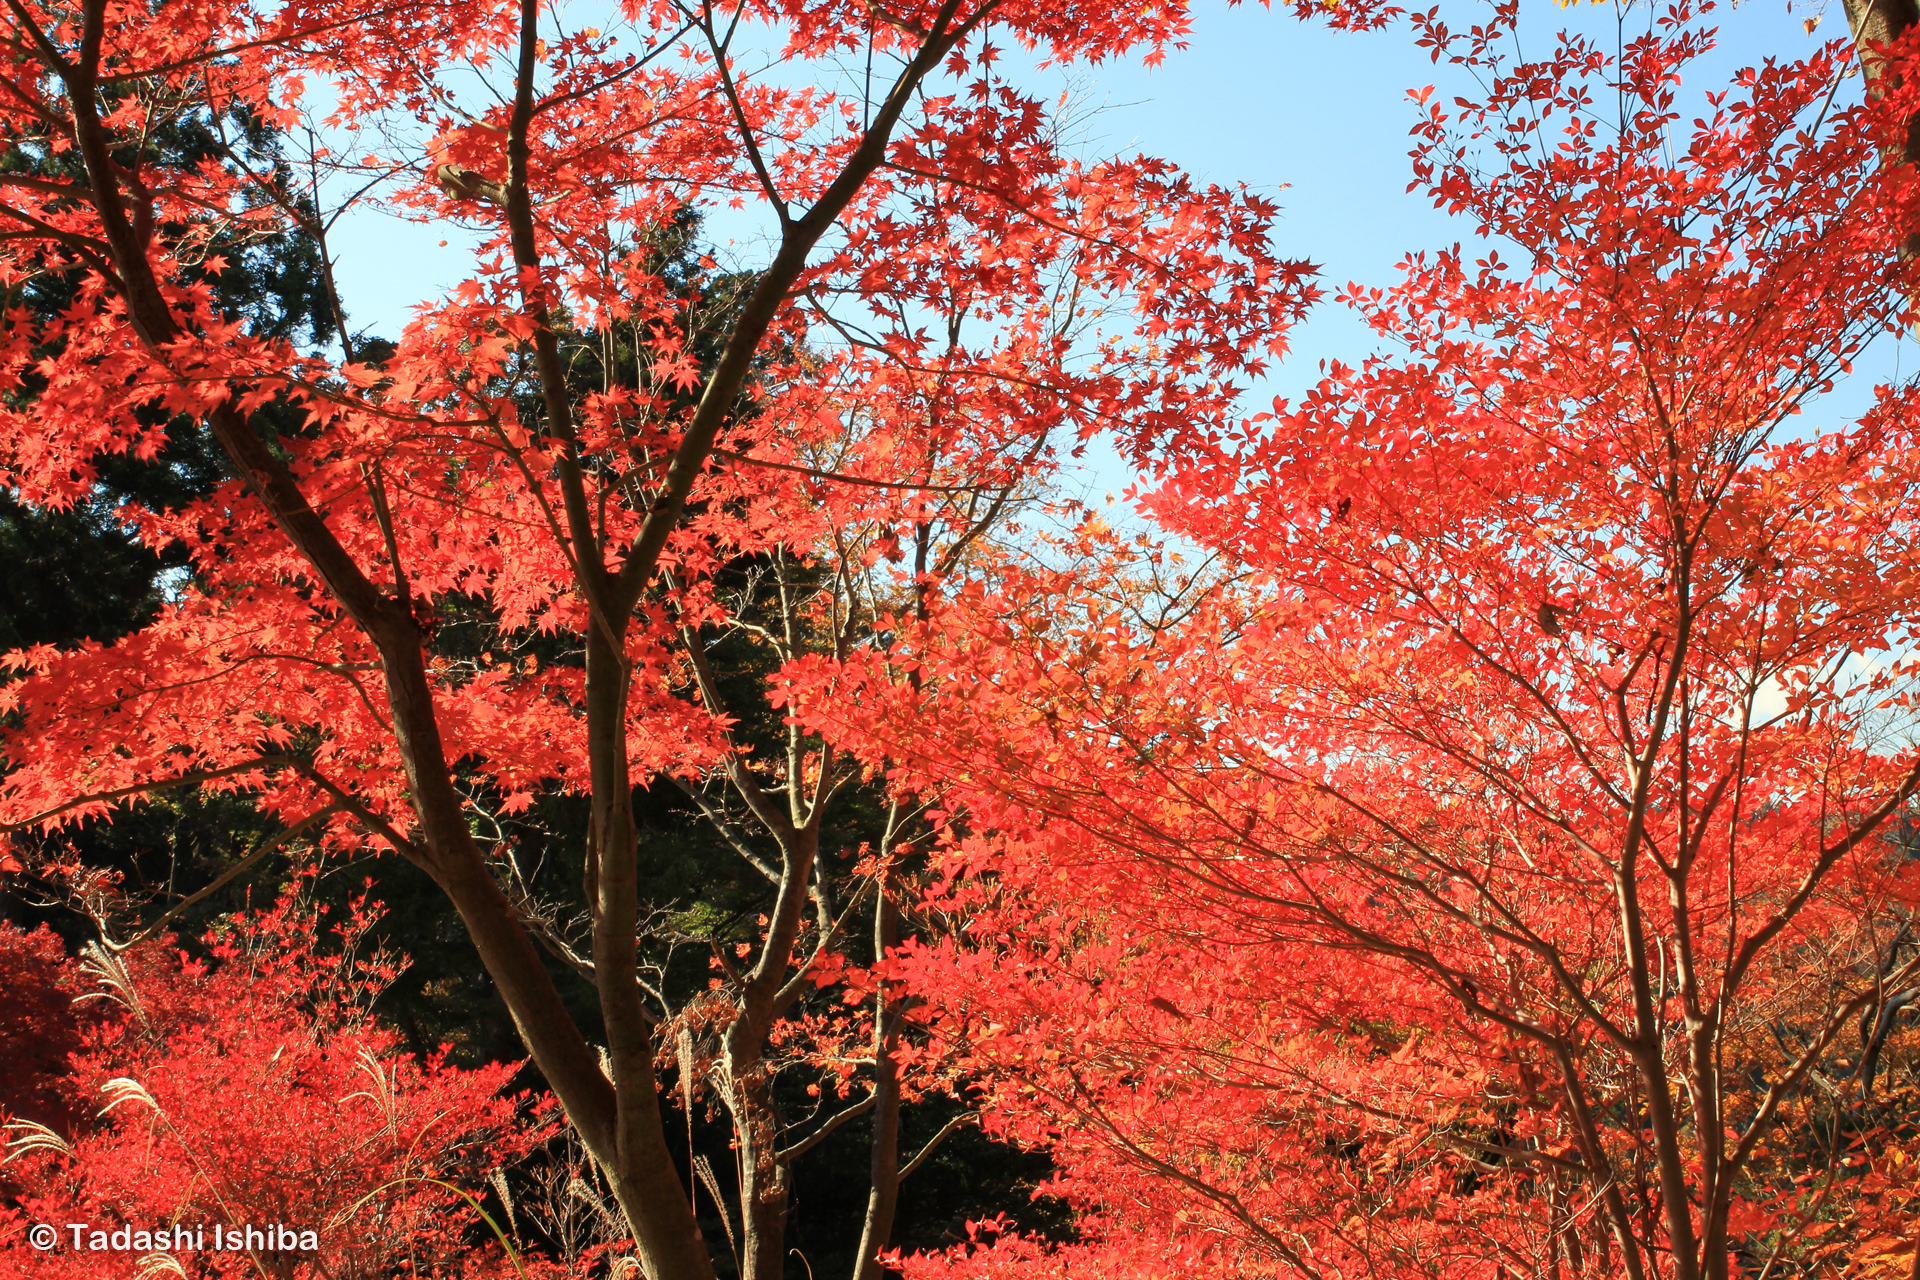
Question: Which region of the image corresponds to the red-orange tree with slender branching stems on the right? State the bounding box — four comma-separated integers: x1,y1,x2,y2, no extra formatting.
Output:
785,4,1920,1280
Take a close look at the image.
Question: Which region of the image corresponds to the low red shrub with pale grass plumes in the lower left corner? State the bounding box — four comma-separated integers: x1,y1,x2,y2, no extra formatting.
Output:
0,898,547,1280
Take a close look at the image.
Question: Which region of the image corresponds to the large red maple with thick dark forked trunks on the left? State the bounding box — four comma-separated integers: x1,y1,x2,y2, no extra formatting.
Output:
0,0,1386,1280
